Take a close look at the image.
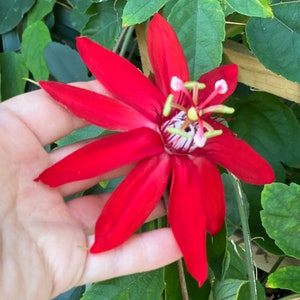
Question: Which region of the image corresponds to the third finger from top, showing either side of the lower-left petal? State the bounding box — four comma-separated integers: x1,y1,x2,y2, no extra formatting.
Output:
67,193,166,234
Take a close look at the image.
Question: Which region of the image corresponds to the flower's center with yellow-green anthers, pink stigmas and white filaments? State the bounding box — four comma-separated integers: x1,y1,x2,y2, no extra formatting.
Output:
160,76,234,154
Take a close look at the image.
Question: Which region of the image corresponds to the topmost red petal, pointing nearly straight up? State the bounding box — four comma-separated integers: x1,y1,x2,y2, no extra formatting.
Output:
147,14,189,96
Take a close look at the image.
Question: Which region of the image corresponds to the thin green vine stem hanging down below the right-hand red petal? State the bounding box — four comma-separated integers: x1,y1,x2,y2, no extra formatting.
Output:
230,173,257,300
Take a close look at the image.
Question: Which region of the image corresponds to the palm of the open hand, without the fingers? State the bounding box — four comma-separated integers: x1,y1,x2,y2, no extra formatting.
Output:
0,101,87,299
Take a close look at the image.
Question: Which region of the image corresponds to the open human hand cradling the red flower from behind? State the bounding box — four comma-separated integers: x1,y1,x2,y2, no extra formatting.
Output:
0,82,181,300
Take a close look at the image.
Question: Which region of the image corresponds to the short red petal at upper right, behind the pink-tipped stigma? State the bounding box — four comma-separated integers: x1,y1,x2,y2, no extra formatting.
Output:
198,65,238,106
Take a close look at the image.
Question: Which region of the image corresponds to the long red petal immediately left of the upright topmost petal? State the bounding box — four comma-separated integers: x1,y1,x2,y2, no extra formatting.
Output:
76,37,165,122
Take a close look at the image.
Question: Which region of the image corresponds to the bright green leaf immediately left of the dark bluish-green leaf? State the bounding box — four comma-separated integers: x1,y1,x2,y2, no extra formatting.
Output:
22,21,51,81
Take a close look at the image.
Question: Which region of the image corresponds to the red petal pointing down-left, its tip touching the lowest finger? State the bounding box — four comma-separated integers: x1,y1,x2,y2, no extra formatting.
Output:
90,154,171,253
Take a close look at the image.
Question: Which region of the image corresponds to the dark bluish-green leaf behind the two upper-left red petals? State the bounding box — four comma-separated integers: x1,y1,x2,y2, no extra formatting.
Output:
44,42,91,83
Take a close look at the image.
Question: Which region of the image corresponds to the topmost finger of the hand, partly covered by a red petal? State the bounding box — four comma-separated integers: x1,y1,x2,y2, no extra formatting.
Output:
1,81,108,145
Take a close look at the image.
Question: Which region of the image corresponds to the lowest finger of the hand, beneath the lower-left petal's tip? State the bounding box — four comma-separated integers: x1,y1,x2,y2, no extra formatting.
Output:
79,228,181,284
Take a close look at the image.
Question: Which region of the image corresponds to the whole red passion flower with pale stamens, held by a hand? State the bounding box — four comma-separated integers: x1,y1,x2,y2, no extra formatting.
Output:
35,14,274,285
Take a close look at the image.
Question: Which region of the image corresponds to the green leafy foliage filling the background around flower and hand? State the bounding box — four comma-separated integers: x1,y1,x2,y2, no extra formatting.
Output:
0,0,300,300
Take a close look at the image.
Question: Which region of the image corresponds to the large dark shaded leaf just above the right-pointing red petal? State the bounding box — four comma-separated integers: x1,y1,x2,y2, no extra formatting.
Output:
229,92,300,181
